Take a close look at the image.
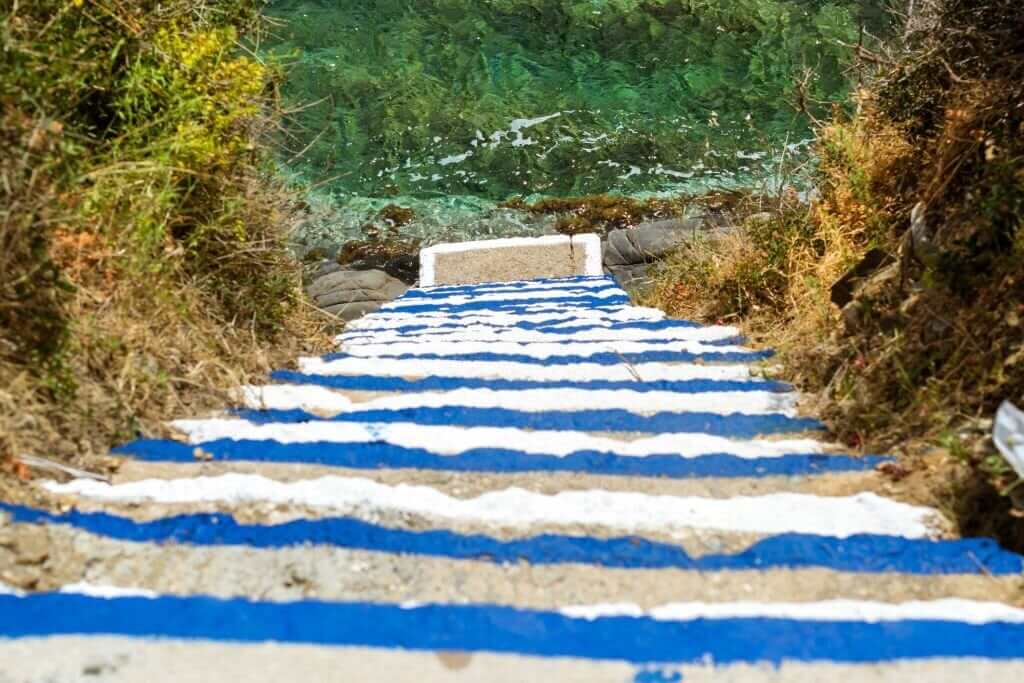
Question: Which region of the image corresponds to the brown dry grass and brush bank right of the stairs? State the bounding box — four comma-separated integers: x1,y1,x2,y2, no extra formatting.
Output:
648,0,1024,550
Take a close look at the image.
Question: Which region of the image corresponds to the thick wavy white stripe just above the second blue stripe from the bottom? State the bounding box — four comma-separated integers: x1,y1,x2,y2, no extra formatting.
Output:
43,473,937,539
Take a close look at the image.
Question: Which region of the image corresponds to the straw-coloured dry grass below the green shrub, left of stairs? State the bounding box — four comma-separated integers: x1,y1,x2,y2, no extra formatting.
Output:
0,242,330,501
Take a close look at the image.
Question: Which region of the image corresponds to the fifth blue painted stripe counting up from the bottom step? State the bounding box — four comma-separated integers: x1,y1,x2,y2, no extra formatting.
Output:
270,370,793,393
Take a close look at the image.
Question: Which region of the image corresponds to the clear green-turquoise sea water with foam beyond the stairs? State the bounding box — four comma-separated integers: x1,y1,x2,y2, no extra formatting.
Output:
263,0,882,241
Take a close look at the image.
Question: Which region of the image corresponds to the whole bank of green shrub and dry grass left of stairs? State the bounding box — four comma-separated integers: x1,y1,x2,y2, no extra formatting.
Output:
0,0,335,500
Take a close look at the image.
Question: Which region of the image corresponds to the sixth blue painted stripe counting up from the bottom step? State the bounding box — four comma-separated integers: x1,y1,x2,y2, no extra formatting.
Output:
323,350,772,366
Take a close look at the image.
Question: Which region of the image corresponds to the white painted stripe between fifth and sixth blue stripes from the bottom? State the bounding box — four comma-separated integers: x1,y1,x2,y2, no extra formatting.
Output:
299,357,752,382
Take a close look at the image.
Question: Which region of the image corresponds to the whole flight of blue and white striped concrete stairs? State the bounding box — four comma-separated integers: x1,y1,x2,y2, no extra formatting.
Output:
0,276,1024,683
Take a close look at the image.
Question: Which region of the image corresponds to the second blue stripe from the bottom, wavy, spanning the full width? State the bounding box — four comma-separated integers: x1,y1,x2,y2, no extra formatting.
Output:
0,503,1024,577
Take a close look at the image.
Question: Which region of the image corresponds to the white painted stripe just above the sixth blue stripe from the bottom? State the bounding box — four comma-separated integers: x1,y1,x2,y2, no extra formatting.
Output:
343,340,751,359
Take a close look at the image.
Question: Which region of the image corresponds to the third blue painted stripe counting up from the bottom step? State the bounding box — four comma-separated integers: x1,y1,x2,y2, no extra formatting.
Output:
114,439,880,478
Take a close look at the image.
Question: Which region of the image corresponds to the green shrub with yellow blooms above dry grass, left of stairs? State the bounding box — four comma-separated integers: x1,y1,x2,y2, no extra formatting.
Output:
0,0,292,368
